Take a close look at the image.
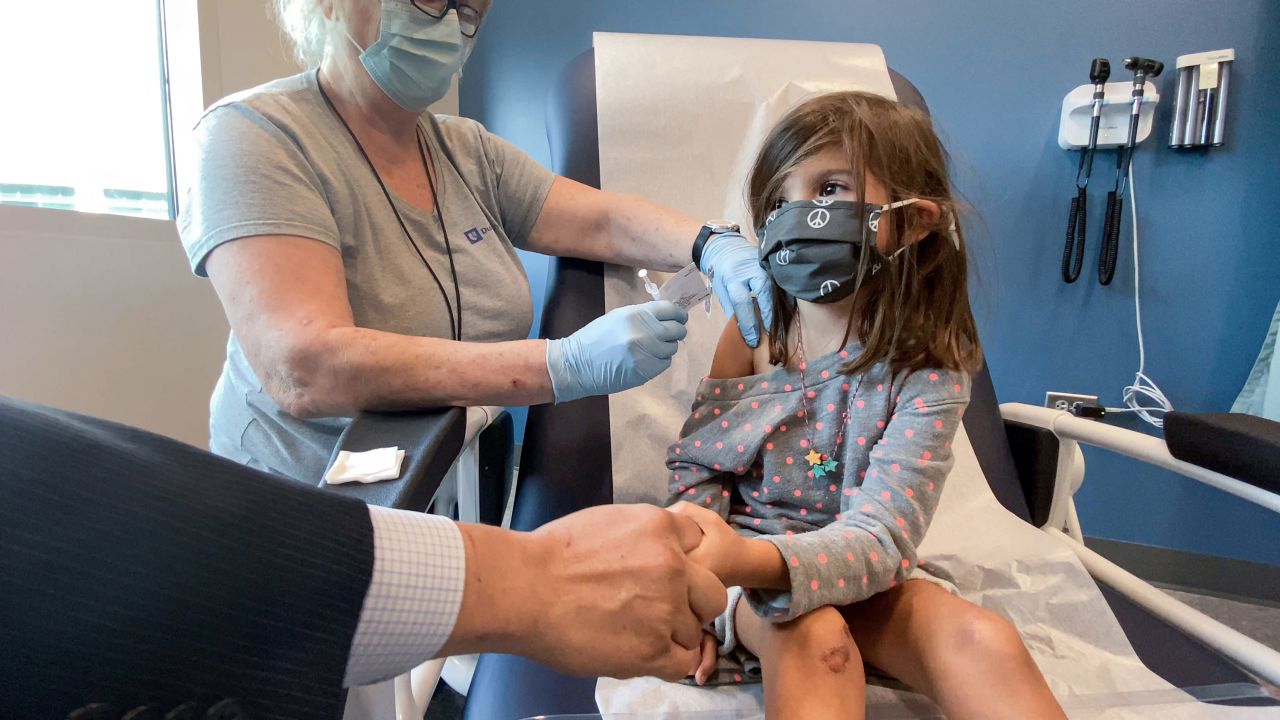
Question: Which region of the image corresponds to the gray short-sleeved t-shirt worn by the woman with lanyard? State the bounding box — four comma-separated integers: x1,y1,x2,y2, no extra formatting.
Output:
178,72,556,483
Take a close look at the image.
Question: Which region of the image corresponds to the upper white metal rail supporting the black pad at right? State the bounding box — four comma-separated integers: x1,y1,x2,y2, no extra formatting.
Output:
1000,402,1280,512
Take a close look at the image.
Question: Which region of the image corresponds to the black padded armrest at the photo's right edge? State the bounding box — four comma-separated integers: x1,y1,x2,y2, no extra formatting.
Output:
1165,413,1280,492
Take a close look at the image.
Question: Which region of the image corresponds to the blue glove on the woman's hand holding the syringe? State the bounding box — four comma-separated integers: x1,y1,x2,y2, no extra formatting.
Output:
547,300,689,402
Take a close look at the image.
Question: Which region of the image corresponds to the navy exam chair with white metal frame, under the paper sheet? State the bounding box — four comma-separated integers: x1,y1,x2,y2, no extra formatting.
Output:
466,50,1280,720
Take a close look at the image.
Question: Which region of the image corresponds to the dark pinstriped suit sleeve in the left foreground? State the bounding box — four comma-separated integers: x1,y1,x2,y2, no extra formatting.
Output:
0,398,374,719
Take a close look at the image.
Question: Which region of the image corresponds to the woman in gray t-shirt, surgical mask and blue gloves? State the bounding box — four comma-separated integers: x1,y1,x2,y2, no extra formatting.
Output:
179,0,772,482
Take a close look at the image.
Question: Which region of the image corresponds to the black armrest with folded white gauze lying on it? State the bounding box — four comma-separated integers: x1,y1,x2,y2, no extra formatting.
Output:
320,407,467,511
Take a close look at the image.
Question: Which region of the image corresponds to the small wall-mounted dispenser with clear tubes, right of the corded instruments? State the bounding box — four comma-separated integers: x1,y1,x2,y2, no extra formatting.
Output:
1169,49,1235,150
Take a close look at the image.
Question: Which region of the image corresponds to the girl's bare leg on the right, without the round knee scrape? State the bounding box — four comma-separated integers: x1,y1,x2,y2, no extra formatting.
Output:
841,580,1066,720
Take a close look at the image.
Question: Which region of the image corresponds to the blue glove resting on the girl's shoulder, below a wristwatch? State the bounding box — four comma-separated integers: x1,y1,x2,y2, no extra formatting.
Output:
698,232,773,347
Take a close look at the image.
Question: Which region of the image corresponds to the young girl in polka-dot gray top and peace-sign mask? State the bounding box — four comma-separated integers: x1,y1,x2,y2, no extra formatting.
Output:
667,92,1064,720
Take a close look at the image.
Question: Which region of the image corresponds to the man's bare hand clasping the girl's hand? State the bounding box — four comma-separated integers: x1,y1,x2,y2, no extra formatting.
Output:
443,505,727,680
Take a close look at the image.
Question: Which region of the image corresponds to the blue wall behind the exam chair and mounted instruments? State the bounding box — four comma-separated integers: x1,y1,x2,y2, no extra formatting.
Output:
462,0,1280,565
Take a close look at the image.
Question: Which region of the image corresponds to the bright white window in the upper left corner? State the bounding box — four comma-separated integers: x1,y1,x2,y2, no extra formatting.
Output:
0,0,173,219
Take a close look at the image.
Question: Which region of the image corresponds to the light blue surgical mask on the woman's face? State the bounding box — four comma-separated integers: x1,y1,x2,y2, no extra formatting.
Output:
347,0,474,113
